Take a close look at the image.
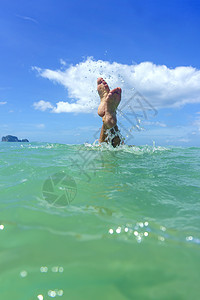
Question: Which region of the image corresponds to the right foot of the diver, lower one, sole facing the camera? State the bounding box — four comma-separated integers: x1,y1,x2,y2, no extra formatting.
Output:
103,87,122,129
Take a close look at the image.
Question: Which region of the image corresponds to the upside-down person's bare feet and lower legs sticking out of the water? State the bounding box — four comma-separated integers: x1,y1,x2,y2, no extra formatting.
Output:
97,77,122,147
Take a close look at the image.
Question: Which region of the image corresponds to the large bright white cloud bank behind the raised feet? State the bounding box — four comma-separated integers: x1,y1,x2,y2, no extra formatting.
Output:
33,58,200,113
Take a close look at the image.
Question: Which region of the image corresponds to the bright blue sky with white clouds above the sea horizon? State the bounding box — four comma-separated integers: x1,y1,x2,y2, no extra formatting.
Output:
0,0,200,147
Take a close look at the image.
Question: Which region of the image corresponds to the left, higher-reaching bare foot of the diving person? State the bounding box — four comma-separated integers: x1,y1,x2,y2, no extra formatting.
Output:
97,77,110,117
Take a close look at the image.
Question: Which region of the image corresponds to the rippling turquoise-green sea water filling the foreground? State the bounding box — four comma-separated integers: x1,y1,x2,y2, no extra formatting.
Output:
0,143,200,300
